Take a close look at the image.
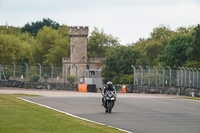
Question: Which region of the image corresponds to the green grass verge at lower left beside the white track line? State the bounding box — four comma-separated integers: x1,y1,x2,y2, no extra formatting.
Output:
0,94,122,133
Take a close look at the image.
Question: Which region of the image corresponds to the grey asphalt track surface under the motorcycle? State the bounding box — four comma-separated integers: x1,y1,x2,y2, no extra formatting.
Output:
25,96,200,133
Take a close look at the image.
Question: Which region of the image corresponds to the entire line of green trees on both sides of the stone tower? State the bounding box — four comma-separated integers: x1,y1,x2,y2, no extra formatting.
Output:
0,19,200,84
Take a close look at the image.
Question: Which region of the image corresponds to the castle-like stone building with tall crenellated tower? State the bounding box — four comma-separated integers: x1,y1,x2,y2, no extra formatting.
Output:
62,27,103,83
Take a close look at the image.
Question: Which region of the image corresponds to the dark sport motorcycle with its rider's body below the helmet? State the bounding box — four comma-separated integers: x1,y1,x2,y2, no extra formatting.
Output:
102,88,116,113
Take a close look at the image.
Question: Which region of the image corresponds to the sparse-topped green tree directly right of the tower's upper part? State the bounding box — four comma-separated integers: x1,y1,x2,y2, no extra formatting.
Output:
87,28,119,57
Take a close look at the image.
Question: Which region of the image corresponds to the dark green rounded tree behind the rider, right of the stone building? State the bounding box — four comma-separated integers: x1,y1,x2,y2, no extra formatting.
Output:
102,46,147,84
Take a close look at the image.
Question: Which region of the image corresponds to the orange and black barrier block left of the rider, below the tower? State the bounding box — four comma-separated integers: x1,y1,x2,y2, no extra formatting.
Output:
78,84,97,92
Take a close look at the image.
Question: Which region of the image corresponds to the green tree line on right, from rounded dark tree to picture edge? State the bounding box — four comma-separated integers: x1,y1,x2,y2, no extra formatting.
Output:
102,24,200,84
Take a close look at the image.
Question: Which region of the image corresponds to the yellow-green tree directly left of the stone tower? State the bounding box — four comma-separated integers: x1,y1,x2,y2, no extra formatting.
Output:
33,26,70,66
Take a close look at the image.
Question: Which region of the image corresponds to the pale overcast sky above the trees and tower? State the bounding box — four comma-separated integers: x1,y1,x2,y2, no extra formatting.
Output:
0,0,200,45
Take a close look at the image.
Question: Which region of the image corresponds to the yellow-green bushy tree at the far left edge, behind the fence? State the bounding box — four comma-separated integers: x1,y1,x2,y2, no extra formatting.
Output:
0,25,36,64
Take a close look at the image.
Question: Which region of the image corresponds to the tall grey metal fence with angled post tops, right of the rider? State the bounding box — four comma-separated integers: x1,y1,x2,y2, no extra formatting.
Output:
132,65,200,88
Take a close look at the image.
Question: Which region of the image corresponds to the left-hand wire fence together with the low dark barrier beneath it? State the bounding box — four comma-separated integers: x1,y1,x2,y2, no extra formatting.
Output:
0,63,77,90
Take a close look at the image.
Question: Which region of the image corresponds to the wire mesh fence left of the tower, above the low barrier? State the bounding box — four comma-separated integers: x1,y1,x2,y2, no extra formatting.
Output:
0,63,67,83
